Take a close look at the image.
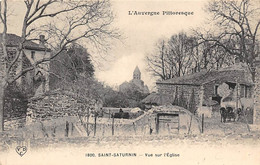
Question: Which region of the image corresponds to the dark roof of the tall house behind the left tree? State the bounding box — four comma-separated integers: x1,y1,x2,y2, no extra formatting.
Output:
0,33,50,51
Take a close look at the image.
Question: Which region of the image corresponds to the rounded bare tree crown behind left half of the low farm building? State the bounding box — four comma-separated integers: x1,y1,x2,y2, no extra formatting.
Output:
146,33,195,80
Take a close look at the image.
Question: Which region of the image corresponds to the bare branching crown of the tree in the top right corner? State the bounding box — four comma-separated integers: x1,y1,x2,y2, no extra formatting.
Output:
198,0,260,74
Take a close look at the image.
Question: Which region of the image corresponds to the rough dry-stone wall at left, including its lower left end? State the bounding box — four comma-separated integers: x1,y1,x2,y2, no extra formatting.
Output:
4,92,99,130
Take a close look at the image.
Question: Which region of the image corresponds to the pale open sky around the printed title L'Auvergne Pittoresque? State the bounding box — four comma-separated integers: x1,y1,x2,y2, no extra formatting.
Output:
3,0,206,91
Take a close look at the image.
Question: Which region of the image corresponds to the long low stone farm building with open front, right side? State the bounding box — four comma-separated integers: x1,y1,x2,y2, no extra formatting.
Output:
156,62,254,122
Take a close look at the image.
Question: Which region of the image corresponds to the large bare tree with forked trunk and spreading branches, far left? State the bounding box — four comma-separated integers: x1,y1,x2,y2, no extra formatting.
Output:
0,0,119,131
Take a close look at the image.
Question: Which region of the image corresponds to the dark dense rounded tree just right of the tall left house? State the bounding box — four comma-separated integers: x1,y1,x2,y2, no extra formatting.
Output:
49,44,94,89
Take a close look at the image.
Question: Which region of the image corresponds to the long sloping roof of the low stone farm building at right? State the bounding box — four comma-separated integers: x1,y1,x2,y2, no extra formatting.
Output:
156,64,253,86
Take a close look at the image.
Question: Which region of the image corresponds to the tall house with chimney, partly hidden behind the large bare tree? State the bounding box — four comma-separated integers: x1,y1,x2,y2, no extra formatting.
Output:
0,34,51,95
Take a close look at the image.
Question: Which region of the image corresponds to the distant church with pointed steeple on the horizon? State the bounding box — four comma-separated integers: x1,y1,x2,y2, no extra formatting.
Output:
119,66,149,93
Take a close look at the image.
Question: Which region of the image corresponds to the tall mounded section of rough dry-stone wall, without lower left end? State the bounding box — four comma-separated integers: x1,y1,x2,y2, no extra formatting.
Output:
26,93,97,124
